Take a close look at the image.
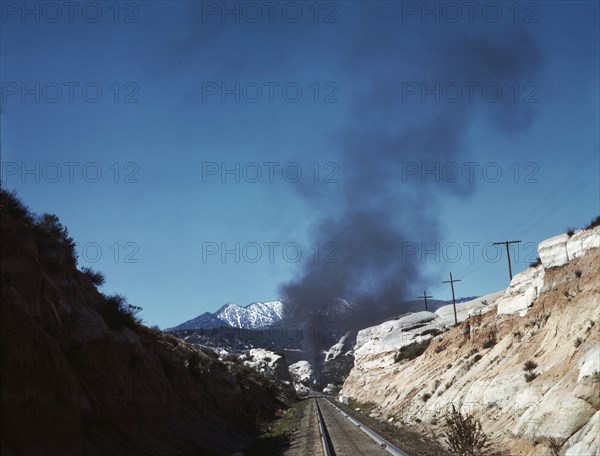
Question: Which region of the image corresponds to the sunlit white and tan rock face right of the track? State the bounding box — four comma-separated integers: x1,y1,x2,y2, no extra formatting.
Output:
341,227,600,456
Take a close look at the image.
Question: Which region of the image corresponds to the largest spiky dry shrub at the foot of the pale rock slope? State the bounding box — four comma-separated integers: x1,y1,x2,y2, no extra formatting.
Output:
444,405,489,456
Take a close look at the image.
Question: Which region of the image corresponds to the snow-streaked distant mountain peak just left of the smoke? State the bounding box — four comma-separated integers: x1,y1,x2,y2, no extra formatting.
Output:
171,301,283,330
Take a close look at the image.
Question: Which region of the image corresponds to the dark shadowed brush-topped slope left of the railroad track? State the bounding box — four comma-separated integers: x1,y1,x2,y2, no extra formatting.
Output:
0,192,290,456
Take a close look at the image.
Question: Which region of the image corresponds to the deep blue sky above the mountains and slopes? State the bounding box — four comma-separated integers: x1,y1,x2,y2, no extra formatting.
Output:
0,1,600,327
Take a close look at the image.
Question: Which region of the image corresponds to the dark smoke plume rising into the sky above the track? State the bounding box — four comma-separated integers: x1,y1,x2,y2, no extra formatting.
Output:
280,25,540,378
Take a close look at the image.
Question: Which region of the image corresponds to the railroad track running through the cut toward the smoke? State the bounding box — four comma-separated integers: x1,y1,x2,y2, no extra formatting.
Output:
313,396,408,456
